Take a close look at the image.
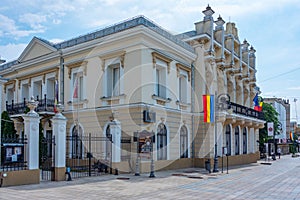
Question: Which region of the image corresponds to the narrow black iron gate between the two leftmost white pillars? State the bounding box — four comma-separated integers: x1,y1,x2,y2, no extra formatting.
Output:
39,132,55,181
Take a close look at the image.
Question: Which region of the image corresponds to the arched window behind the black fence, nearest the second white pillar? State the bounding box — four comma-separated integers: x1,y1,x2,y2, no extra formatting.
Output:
71,125,82,158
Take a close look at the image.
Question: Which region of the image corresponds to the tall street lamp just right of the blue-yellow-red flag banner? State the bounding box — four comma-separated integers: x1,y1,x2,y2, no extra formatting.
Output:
213,93,230,172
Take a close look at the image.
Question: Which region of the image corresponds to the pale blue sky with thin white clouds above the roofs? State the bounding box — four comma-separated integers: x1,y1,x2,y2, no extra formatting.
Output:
0,0,300,123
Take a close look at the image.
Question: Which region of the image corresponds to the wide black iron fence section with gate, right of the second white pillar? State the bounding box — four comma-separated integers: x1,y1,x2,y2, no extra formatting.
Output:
66,134,112,178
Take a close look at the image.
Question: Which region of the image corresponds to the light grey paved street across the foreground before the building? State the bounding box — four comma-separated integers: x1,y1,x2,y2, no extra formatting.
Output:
0,155,300,200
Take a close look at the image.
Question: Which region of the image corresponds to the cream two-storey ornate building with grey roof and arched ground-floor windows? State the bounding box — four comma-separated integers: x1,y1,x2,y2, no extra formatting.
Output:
0,6,264,171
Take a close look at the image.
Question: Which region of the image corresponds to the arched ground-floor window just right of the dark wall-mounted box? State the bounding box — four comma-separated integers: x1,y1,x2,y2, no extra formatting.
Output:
157,123,167,160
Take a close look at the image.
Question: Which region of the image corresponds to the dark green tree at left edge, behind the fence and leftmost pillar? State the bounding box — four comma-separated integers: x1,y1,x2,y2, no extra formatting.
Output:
1,111,17,138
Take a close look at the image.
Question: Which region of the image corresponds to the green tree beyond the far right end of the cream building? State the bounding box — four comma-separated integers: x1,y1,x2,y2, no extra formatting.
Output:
259,103,280,152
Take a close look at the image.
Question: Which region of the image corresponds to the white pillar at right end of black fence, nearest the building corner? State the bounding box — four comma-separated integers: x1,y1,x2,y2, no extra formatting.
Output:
110,121,121,162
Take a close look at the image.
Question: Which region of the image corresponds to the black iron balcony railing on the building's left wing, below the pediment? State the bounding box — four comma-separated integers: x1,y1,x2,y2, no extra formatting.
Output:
6,94,54,115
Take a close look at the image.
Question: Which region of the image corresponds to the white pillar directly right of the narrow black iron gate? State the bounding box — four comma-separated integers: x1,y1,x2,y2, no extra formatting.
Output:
51,113,67,167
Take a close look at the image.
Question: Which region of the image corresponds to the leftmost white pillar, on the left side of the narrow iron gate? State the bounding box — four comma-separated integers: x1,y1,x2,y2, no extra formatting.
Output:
23,107,40,169
